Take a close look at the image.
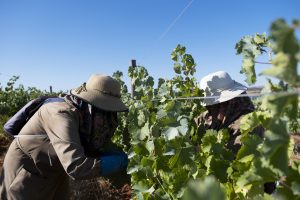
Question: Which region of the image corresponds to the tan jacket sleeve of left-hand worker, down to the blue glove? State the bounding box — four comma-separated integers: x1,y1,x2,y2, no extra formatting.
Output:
42,105,100,179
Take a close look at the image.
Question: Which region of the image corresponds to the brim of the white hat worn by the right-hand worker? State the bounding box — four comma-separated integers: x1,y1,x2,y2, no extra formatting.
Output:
203,82,248,106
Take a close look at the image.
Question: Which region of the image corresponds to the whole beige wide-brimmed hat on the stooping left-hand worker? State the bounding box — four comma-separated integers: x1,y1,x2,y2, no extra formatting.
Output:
70,74,128,112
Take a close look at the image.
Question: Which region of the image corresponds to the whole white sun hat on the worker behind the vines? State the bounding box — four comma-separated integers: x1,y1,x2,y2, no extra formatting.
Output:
200,71,248,106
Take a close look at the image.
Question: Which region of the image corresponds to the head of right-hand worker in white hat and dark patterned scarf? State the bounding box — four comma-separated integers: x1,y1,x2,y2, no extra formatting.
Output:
200,71,254,133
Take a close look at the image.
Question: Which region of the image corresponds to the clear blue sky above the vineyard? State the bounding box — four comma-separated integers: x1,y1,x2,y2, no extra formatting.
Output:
0,0,300,91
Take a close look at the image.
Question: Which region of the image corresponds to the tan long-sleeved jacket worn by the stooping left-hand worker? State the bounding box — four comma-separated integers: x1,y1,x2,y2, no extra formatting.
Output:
0,99,100,200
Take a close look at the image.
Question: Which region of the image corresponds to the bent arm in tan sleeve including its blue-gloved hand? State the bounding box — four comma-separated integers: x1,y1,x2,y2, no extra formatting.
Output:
44,104,128,179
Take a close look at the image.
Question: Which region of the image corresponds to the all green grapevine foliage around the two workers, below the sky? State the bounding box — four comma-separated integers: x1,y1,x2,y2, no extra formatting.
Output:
0,19,300,200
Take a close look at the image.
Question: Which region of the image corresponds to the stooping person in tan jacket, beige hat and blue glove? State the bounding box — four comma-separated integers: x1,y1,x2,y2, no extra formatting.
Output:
0,74,128,200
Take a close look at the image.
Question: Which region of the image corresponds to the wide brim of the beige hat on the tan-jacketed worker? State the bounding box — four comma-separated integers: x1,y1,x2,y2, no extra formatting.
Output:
70,89,128,112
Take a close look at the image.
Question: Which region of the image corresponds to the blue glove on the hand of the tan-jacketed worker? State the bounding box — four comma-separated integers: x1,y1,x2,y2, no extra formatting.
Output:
100,151,128,176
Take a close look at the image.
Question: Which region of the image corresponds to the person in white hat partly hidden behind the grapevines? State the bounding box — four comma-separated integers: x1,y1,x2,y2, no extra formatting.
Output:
196,71,275,193
